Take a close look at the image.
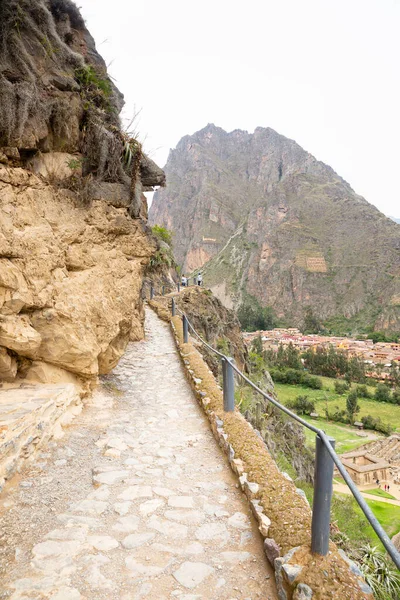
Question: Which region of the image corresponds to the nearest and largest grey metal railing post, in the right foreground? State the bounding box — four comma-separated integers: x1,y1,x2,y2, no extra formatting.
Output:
311,435,335,556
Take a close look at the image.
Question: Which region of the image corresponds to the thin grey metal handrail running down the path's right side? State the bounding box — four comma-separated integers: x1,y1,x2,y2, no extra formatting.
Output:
155,292,400,569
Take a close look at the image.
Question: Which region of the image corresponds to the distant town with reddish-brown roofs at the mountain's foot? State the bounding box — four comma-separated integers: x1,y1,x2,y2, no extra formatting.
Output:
243,328,400,380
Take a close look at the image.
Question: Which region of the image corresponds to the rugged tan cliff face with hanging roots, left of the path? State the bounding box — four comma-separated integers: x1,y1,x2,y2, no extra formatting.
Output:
0,0,165,382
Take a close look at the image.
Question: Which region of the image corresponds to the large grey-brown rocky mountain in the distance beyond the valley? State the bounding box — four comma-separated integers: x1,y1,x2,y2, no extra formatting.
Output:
150,125,400,330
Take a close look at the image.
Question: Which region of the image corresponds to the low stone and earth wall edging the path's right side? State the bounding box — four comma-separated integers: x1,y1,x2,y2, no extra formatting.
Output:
152,303,373,600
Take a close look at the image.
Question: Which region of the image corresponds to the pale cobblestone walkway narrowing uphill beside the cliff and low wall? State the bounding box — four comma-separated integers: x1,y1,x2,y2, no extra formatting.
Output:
0,311,277,600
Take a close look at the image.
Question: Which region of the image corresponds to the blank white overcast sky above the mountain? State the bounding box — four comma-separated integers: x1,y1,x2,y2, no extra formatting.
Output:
77,0,400,216
